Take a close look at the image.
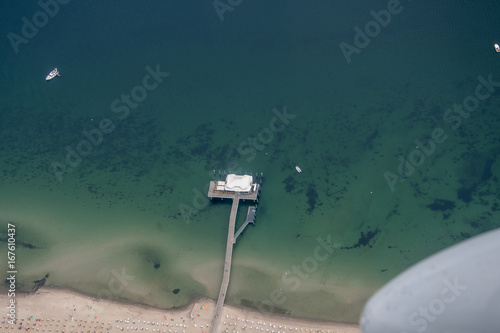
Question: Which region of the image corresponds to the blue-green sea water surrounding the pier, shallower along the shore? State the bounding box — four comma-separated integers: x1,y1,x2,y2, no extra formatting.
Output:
0,1,500,322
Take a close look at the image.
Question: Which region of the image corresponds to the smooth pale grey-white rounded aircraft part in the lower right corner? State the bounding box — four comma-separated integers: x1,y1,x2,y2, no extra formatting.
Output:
360,229,500,333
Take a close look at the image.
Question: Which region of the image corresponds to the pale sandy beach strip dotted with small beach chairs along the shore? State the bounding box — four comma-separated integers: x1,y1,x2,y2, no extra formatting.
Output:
0,287,361,333
